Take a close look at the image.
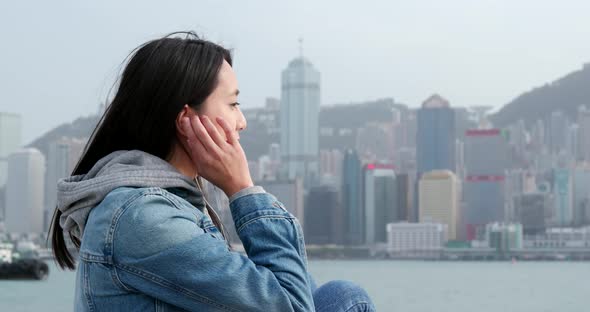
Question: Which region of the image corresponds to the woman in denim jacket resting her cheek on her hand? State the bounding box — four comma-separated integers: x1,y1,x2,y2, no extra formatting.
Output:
51,33,374,311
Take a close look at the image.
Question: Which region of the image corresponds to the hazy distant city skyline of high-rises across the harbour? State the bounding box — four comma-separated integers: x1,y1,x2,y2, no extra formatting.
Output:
0,55,590,260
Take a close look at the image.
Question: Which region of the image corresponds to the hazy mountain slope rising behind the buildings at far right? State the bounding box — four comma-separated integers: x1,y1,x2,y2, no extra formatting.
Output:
490,63,590,127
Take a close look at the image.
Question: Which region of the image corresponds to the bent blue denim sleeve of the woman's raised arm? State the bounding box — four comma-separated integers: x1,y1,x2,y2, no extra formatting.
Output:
112,186,314,311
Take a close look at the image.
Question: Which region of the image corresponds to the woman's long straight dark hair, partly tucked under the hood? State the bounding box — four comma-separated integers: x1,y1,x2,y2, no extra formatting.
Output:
48,32,232,270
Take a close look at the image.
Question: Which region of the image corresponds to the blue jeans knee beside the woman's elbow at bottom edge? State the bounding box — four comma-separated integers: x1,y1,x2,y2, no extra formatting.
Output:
312,279,376,312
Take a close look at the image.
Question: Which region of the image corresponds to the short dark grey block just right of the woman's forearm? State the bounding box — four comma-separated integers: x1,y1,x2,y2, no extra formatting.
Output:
304,185,344,245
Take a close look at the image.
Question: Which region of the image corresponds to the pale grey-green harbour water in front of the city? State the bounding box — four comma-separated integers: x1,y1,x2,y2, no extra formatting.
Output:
0,260,590,312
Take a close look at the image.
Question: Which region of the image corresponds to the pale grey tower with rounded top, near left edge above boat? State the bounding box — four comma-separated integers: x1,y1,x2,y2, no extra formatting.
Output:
5,148,45,233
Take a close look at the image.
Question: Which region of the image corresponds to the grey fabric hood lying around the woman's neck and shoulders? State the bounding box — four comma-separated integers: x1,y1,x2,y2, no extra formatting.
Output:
57,150,205,239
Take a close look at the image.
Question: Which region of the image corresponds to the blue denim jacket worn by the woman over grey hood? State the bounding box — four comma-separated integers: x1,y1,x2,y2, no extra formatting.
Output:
75,187,313,312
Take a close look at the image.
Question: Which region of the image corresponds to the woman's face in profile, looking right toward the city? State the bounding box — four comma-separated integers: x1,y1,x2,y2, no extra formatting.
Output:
198,61,246,140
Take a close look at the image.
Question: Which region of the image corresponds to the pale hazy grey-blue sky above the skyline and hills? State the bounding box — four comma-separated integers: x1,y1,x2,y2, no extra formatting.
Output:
0,0,590,144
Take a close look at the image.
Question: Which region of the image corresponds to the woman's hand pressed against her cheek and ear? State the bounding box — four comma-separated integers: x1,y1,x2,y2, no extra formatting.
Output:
181,115,254,197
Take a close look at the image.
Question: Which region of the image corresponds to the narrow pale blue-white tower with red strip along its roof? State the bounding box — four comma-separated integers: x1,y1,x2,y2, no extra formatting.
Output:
363,164,398,245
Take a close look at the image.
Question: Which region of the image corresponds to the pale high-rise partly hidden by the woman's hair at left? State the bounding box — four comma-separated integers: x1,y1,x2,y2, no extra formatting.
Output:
44,138,86,230
